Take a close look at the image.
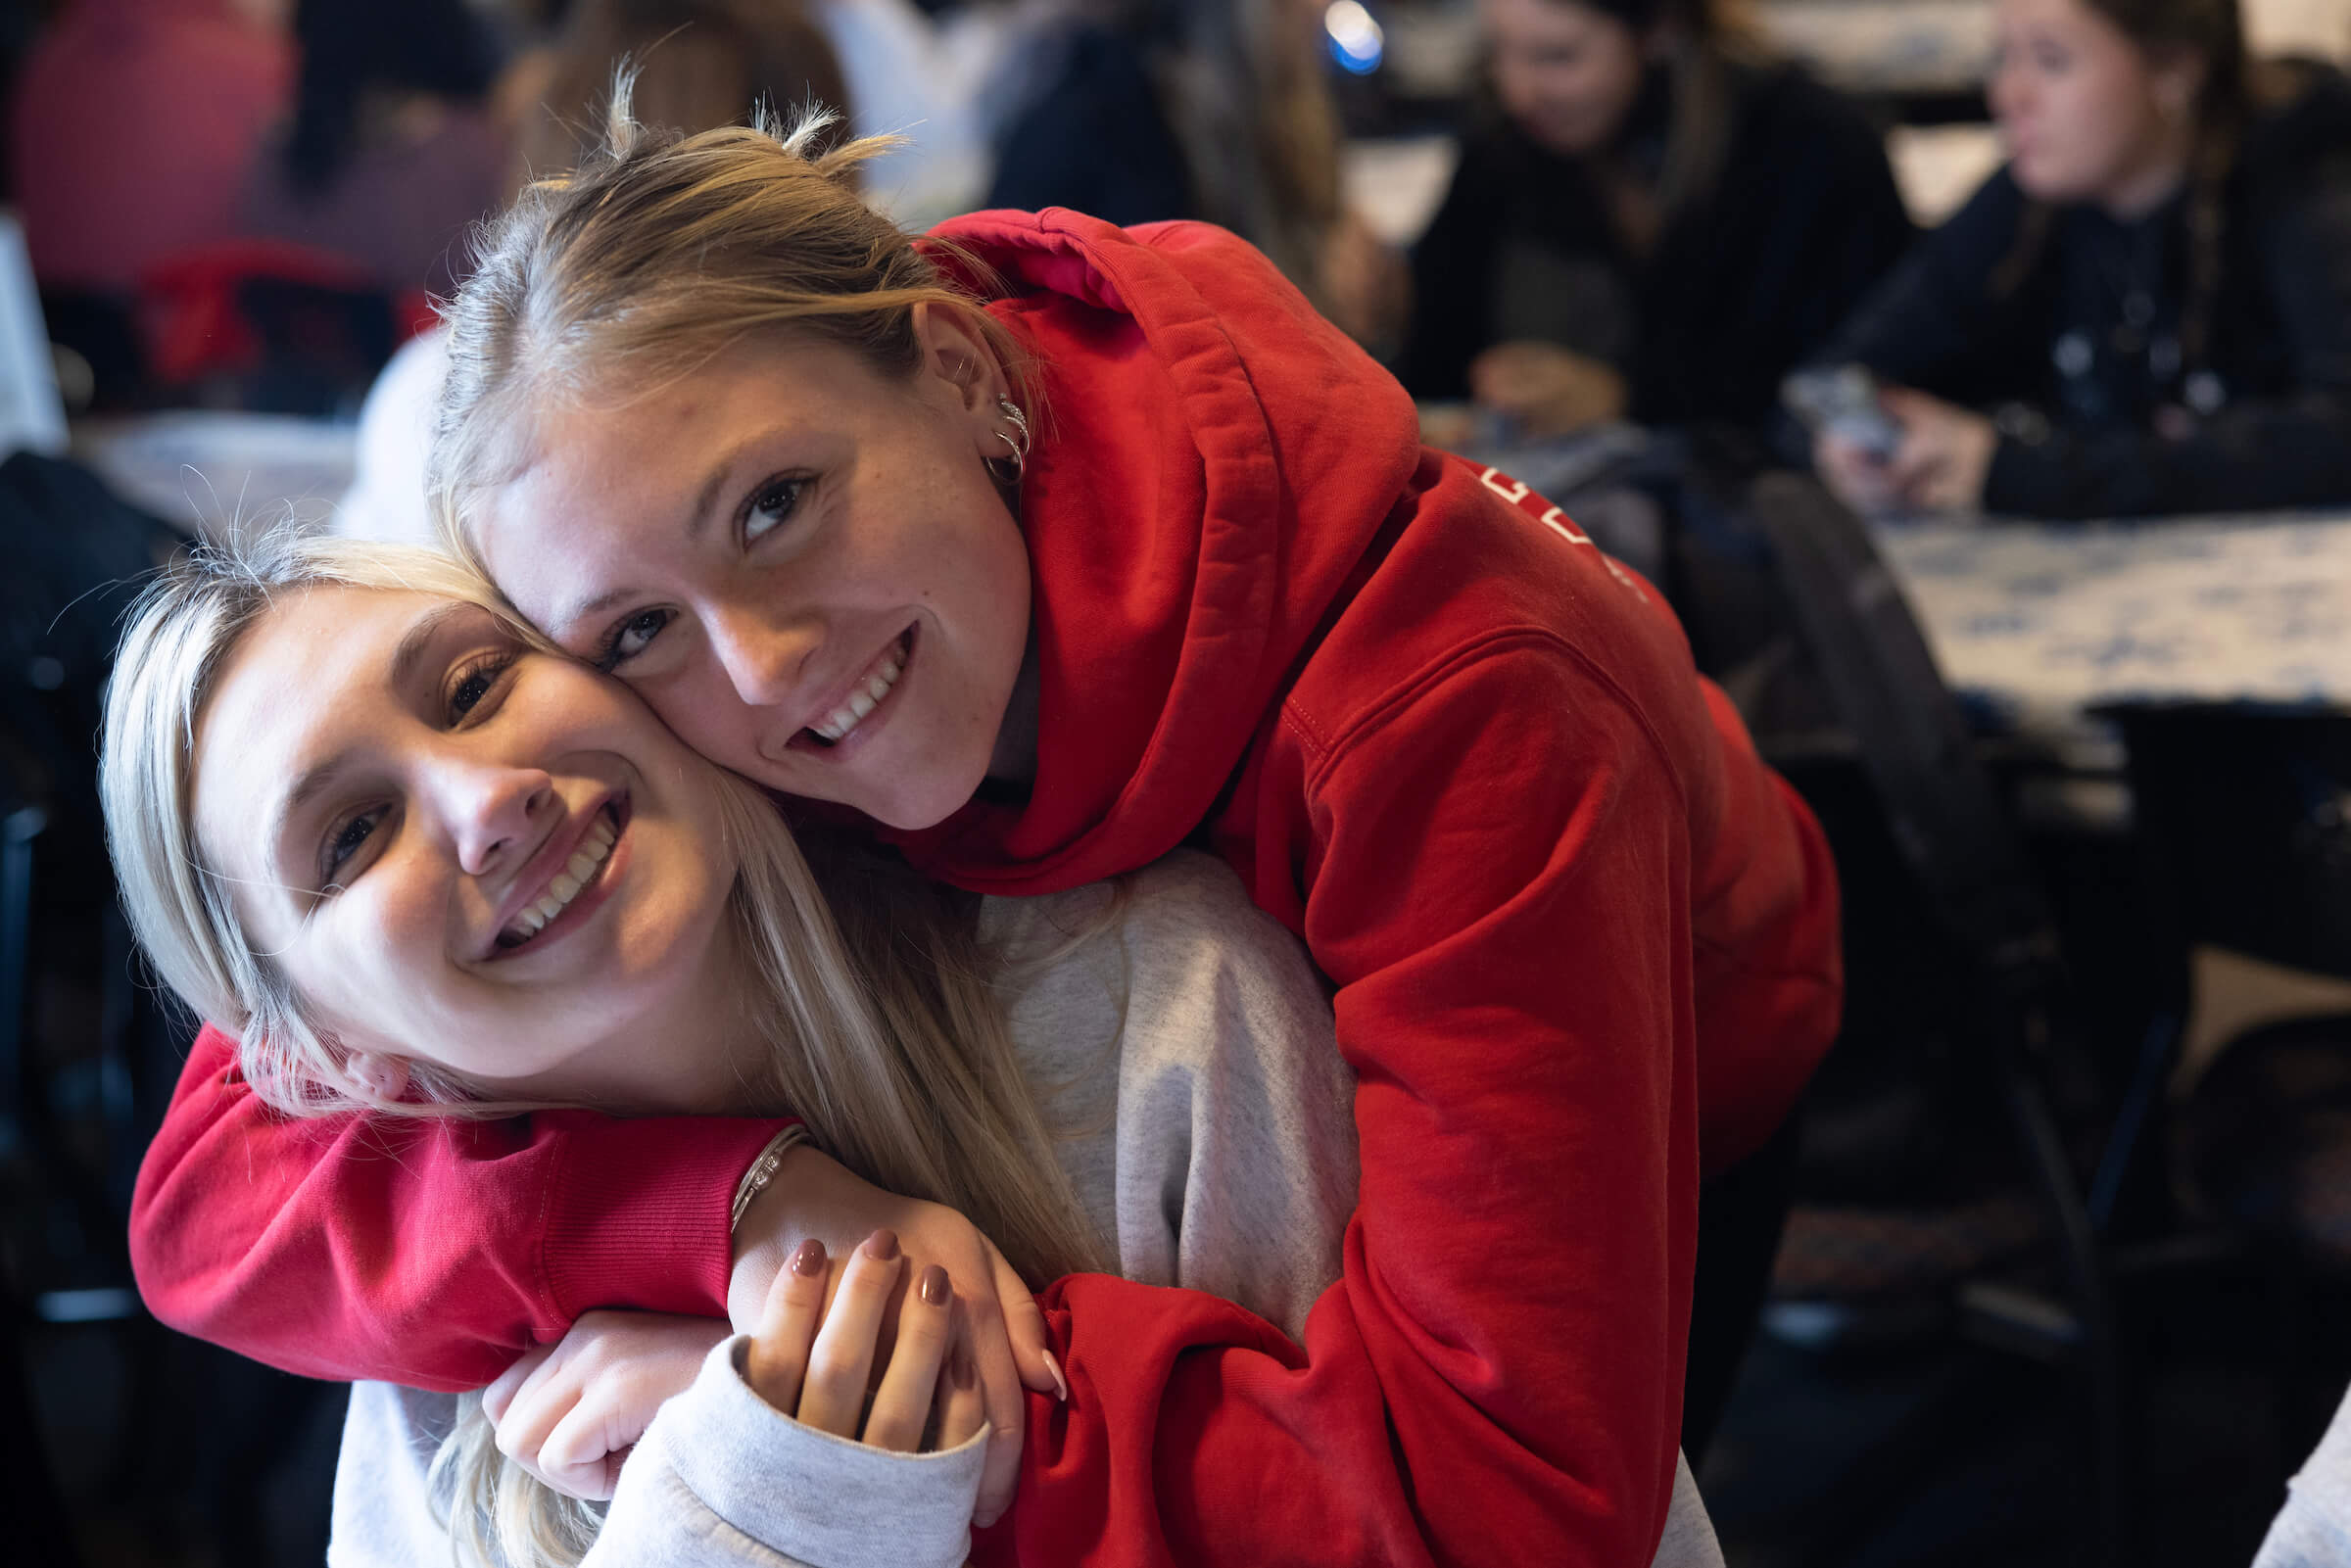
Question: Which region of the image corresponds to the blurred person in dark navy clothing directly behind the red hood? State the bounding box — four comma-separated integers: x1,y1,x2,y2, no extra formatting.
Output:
978,0,1404,341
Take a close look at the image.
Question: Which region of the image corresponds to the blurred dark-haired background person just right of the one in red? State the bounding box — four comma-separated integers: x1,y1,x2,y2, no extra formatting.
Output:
245,0,512,294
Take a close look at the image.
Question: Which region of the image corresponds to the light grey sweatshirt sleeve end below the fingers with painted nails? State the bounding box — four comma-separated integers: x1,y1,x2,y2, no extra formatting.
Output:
606,1335,987,1568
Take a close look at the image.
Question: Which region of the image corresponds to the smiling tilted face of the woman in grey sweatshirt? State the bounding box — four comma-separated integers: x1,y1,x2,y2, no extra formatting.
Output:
193,588,747,1110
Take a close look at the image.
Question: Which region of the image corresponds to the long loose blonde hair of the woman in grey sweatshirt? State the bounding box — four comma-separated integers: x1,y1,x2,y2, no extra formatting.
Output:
99,529,1103,1563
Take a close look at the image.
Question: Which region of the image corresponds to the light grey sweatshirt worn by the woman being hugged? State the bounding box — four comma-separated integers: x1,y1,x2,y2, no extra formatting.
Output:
327,853,1721,1568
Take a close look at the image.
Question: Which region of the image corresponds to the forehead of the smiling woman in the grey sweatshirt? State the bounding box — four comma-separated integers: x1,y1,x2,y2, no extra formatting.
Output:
195,586,447,877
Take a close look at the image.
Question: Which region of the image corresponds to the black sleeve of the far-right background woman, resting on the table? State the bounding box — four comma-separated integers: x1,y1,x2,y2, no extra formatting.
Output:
1985,165,2351,517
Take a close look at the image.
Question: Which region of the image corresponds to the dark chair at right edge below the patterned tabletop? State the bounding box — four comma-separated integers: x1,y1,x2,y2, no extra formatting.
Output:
2099,703,2351,1455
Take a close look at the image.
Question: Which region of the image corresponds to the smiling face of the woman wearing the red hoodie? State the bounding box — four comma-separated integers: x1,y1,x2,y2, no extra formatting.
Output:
470,308,1030,828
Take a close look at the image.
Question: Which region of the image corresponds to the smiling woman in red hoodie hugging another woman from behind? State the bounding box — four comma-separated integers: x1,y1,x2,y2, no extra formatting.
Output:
134,104,1839,1563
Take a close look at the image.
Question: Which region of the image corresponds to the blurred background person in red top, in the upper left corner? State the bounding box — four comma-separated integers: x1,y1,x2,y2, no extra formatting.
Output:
12,0,294,294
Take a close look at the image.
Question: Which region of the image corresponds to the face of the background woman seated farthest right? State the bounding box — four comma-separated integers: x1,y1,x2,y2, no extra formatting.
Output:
1985,0,2203,216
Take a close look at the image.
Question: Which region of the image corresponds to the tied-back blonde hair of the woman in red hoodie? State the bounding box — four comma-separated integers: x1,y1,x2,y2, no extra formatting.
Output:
430,85,1028,554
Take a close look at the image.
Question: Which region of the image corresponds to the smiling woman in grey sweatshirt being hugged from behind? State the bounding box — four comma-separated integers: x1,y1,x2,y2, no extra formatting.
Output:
104,536,1718,1568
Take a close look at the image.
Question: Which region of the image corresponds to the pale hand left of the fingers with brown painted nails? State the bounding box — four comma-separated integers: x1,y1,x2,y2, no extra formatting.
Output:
482,1311,727,1502
